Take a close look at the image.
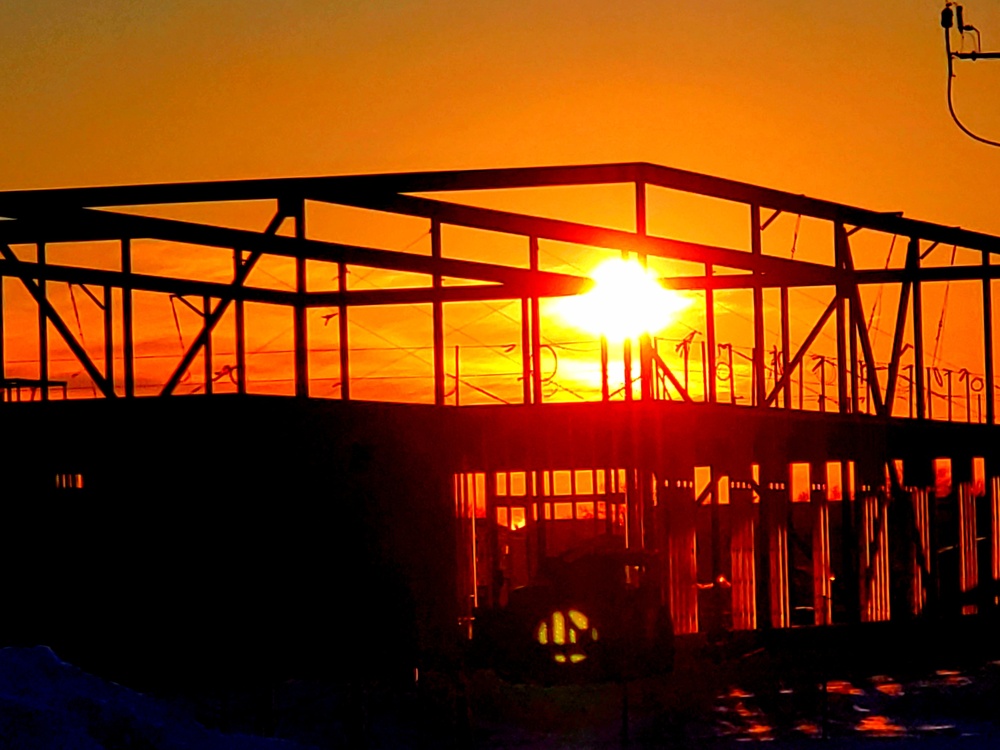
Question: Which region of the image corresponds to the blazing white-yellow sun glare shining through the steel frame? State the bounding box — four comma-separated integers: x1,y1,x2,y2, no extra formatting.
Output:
555,258,691,342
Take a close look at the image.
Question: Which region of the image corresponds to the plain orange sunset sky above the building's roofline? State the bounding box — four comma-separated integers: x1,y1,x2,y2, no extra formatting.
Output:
0,0,1000,412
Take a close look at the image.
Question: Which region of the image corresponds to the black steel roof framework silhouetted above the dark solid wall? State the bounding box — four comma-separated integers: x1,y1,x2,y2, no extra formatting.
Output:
0,163,1000,424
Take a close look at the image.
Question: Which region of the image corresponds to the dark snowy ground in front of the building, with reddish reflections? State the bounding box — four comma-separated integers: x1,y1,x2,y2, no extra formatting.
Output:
0,632,1000,750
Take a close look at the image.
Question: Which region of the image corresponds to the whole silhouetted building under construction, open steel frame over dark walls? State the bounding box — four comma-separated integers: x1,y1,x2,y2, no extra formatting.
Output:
0,164,1000,672
